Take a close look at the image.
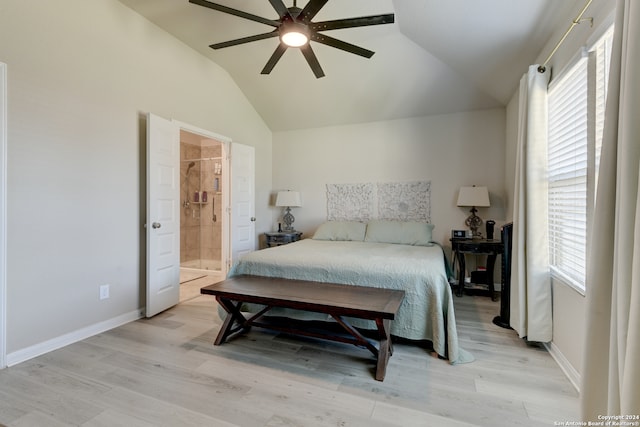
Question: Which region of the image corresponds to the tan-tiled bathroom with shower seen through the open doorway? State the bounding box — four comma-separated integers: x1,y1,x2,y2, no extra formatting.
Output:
180,130,226,301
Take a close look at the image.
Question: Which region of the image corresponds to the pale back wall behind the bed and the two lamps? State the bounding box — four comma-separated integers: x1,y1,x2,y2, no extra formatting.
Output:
272,109,505,244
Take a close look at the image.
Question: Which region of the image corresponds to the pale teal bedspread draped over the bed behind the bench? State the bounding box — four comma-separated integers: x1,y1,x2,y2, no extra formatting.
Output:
229,239,473,363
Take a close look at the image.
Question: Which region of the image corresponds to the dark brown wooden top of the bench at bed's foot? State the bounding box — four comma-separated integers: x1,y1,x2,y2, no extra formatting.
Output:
200,275,404,320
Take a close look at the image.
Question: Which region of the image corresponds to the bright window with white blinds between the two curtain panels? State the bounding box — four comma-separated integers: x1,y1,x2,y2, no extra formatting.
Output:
548,28,613,292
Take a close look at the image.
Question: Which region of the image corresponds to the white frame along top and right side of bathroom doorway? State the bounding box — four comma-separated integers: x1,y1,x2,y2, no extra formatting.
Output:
171,120,232,277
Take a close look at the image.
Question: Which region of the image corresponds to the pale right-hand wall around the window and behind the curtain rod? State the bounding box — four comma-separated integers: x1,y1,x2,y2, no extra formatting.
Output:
505,0,615,385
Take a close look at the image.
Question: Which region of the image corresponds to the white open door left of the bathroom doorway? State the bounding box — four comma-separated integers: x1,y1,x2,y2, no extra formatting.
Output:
145,114,180,317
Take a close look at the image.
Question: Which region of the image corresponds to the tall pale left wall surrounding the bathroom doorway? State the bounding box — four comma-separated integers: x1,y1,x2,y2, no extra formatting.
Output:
0,0,272,362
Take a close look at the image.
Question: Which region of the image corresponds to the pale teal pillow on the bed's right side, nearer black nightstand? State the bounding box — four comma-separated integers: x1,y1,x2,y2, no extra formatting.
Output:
364,220,434,246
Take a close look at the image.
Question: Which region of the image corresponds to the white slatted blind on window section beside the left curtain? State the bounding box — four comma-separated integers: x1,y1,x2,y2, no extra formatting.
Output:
548,58,588,288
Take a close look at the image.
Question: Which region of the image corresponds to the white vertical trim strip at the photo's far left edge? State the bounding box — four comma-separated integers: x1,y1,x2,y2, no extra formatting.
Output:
0,62,7,369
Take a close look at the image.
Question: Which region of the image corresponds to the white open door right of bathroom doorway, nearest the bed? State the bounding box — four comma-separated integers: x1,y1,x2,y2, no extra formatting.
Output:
230,142,256,262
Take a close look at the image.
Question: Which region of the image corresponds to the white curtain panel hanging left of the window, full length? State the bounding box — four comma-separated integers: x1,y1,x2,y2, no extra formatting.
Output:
510,65,553,342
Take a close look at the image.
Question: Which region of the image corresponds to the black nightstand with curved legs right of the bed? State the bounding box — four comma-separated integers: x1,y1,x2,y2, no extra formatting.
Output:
451,239,504,301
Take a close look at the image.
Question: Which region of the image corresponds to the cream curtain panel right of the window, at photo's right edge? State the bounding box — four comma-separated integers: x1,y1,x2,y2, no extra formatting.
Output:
581,0,640,422
